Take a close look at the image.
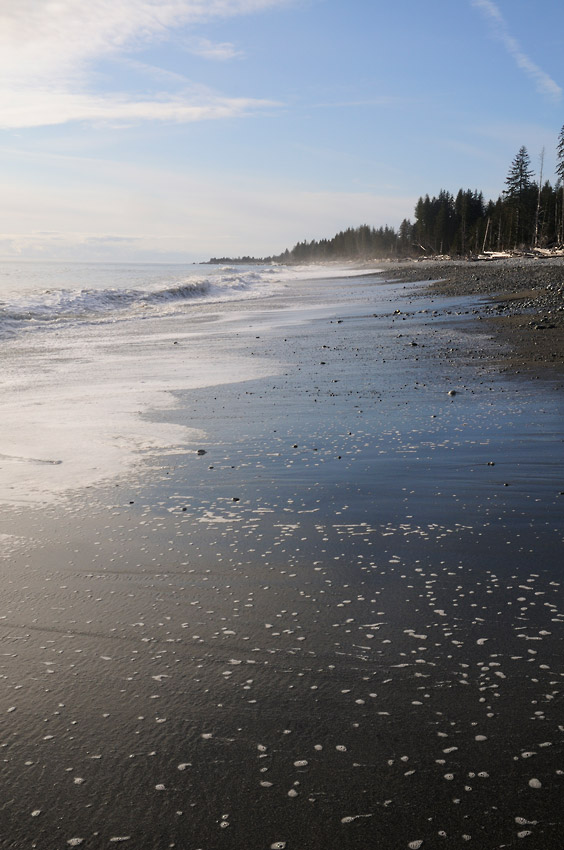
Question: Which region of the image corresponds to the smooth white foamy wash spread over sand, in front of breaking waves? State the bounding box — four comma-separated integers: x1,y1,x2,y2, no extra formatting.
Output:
0,310,277,503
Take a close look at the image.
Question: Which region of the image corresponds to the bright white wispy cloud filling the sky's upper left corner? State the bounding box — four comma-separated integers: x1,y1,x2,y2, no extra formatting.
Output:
0,0,289,128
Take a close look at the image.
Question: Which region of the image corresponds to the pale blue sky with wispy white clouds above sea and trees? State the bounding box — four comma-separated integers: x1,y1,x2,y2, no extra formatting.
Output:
0,0,564,262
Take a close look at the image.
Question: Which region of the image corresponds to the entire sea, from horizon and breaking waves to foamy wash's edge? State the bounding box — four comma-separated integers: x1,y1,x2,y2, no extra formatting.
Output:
0,262,378,503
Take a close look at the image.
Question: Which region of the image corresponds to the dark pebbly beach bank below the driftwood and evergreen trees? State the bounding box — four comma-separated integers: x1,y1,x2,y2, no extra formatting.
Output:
386,257,564,373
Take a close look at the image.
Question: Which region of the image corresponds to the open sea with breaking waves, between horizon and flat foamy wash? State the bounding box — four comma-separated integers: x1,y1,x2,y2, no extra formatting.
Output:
0,264,384,339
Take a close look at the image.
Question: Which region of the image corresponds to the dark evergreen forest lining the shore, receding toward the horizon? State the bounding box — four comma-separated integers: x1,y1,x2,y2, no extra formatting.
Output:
210,126,564,263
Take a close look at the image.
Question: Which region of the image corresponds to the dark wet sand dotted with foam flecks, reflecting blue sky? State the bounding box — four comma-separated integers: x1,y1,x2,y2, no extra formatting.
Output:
0,276,564,850
